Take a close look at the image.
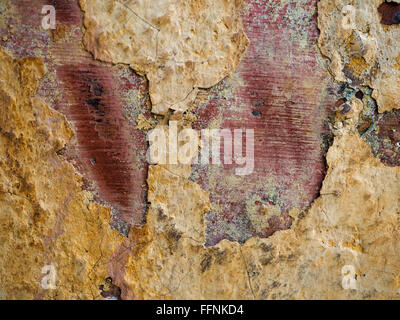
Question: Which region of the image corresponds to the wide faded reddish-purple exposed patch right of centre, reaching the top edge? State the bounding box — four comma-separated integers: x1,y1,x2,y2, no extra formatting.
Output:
193,0,338,245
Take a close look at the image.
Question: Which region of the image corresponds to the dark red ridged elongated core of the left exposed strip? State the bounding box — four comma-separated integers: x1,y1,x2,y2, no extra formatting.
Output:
57,64,145,225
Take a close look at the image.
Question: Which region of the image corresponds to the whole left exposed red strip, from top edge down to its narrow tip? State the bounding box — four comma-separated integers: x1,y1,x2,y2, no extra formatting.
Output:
12,0,148,226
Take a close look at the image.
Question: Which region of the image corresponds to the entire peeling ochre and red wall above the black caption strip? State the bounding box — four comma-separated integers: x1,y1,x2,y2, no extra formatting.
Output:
0,0,400,299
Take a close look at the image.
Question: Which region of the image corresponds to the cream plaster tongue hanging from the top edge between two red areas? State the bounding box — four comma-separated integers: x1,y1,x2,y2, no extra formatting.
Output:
80,0,248,114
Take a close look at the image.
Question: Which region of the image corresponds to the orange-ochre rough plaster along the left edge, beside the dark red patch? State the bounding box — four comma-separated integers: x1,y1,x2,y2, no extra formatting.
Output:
0,51,123,299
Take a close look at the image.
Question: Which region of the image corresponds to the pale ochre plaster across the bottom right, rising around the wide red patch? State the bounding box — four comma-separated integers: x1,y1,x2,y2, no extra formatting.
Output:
125,99,400,299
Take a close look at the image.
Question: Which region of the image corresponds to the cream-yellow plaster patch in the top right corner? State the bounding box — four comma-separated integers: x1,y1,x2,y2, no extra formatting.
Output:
318,0,400,112
